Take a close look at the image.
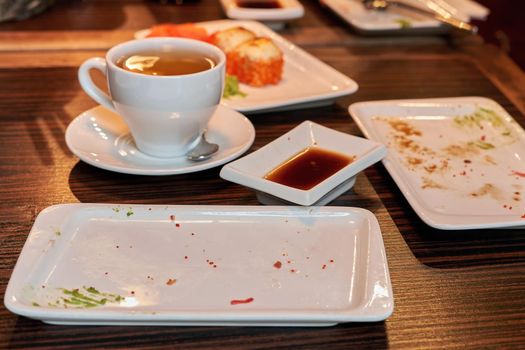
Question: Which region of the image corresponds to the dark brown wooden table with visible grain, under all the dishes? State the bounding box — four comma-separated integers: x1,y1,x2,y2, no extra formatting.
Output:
0,0,525,349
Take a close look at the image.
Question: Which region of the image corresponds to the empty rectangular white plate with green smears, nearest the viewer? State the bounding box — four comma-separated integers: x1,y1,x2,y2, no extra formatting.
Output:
4,204,393,326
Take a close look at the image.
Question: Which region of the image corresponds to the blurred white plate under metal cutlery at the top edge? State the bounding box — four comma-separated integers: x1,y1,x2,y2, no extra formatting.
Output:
320,0,489,33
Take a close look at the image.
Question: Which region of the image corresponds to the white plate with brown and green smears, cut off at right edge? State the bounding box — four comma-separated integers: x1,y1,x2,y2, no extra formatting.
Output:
349,97,525,230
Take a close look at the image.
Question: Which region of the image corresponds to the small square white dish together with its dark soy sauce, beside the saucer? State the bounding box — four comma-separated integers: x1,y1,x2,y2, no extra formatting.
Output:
220,121,387,206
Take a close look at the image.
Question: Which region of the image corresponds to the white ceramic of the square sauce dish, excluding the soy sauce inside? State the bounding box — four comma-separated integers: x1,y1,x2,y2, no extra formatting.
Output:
220,121,386,205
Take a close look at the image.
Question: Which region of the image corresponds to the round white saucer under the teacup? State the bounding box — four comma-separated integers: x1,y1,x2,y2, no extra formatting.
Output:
66,106,255,175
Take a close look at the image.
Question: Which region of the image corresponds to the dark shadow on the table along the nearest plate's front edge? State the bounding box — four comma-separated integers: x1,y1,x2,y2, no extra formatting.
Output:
7,317,388,350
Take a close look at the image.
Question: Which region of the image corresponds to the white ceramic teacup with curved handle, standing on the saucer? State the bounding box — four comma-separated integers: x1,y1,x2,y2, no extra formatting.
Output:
78,38,226,157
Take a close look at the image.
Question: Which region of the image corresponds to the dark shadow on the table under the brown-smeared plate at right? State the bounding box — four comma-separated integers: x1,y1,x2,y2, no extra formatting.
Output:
369,166,525,269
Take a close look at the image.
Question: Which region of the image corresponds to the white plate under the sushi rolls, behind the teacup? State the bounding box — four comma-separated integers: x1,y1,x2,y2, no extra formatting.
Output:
135,20,358,113
